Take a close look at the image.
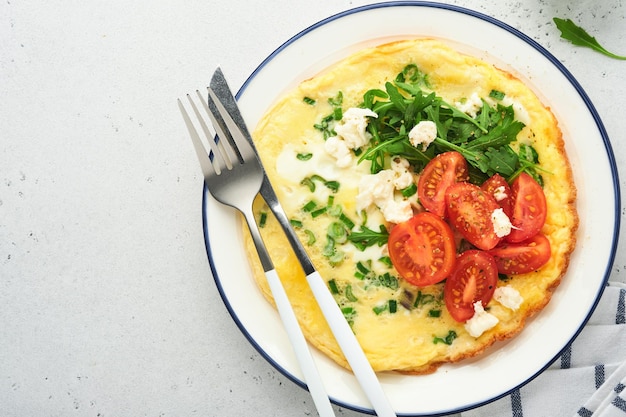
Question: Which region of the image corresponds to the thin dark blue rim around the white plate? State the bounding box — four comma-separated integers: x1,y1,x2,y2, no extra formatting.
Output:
202,1,620,417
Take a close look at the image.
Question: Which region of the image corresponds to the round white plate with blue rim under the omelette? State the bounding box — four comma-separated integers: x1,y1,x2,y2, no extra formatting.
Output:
204,2,619,415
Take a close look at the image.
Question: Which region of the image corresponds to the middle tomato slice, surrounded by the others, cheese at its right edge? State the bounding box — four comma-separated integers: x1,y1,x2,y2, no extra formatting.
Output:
446,182,500,250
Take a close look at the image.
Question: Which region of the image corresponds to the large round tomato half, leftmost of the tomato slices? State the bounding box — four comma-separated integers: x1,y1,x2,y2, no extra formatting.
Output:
388,211,456,287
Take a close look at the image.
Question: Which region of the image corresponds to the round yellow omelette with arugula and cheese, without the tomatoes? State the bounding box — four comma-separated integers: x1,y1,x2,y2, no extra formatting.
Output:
245,39,578,374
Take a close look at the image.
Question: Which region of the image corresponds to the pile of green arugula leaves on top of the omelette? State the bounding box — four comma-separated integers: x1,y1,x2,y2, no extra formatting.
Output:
359,65,539,183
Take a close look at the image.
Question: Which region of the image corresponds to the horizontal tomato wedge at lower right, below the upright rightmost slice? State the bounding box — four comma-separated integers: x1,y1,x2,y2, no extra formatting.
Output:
489,233,551,275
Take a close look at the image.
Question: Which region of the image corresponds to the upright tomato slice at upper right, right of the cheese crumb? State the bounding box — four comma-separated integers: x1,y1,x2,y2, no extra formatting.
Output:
506,172,547,242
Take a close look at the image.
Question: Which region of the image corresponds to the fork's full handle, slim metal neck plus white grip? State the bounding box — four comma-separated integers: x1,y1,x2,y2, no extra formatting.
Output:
242,211,335,417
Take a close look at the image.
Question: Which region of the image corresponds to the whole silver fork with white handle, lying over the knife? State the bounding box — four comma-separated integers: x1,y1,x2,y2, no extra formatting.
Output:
178,88,335,417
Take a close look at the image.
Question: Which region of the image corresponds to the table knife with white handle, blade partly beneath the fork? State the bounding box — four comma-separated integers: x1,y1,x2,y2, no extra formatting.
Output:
209,67,396,417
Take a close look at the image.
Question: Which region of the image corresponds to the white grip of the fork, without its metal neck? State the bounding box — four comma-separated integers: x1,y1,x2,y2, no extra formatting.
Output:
265,269,334,417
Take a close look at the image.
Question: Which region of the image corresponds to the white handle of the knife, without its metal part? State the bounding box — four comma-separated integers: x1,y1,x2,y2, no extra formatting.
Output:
306,271,396,417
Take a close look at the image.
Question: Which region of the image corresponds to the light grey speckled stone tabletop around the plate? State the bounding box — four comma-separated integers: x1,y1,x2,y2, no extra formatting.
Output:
0,0,626,417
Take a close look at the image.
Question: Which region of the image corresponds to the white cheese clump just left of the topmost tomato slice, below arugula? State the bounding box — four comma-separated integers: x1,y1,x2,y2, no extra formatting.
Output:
356,169,413,223
